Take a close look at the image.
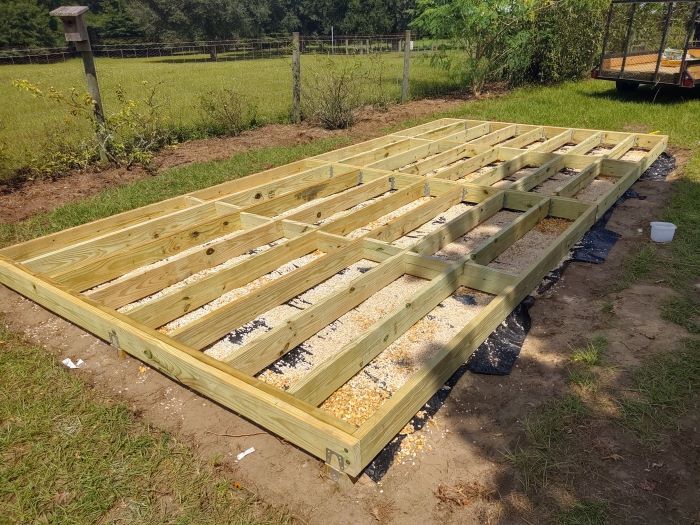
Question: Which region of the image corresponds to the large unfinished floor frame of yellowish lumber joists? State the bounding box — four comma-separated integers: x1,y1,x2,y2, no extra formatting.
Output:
0,119,667,476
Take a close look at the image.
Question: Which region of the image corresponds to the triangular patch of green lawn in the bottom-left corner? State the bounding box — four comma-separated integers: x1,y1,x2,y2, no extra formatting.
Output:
0,319,291,525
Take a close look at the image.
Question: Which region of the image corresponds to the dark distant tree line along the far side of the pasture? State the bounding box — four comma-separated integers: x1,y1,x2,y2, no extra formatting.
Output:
0,0,422,47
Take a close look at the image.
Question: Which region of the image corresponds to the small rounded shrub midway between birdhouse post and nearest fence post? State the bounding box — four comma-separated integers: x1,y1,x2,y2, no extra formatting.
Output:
200,88,258,136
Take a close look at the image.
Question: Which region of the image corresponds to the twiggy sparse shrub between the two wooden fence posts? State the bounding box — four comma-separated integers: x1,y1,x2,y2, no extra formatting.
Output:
302,59,363,129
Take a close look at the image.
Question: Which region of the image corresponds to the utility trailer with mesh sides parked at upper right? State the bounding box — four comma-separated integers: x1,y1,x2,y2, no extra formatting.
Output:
591,0,700,91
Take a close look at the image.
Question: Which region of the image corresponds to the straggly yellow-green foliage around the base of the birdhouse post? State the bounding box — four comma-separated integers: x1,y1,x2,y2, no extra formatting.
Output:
13,80,172,176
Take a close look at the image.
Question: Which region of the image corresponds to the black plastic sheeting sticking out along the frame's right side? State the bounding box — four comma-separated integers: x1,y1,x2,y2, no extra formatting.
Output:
364,153,676,482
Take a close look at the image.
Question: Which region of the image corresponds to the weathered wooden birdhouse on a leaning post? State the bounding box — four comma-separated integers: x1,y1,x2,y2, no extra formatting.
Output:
49,5,107,161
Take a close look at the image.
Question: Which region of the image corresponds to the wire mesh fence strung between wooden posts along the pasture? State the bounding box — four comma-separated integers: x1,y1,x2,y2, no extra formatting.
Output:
0,34,459,174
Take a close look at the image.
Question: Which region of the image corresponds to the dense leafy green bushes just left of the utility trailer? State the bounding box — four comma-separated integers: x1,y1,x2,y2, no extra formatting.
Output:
413,0,608,94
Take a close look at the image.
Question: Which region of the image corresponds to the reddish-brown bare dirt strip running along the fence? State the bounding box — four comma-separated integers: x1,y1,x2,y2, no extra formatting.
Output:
0,98,476,222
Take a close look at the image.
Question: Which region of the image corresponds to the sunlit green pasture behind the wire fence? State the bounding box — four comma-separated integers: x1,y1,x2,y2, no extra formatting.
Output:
0,53,456,170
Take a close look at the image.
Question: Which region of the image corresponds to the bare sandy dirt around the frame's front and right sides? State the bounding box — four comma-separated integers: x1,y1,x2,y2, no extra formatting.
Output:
0,158,700,524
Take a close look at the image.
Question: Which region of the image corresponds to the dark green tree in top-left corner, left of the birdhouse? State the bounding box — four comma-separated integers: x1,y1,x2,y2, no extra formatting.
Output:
0,0,57,47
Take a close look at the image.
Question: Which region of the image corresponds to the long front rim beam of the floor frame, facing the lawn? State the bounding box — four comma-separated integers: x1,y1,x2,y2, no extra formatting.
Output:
0,257,363,473
